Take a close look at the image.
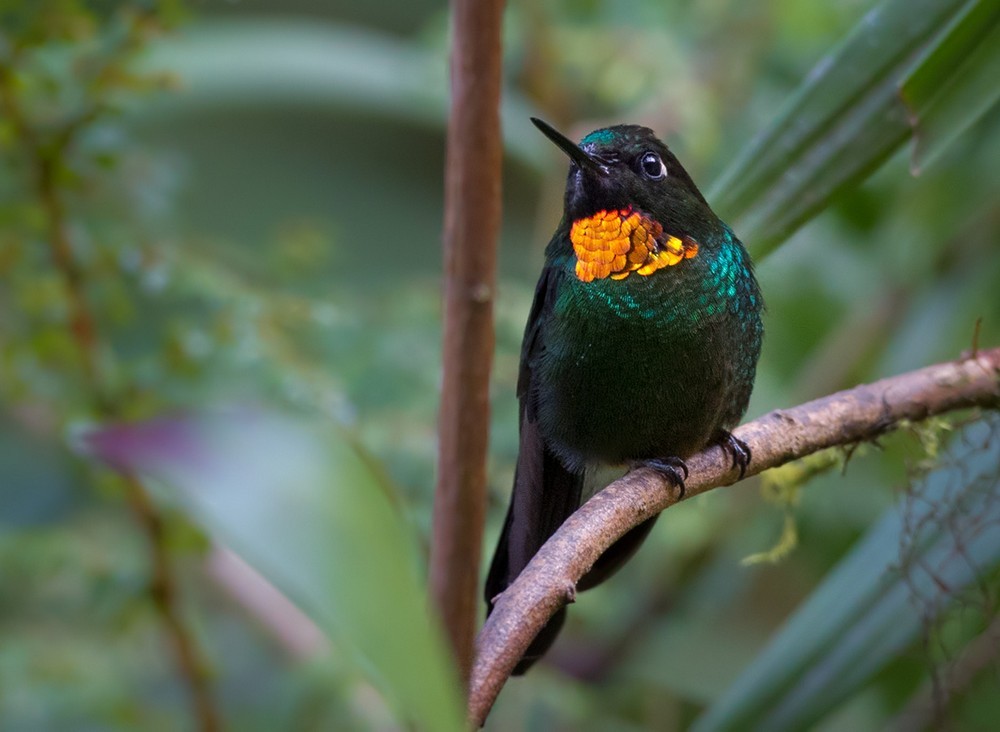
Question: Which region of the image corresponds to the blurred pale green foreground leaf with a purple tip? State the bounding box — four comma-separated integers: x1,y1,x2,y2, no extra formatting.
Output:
81,412,464,730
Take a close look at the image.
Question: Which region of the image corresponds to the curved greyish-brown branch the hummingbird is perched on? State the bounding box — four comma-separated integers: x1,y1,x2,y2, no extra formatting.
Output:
469,348,1000,725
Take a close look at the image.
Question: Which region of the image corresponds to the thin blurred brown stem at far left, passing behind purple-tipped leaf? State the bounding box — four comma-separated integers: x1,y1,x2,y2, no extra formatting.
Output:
0,68,221,732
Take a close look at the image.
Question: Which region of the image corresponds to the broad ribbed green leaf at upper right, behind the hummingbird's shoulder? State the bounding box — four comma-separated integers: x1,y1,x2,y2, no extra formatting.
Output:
709,0,1000,257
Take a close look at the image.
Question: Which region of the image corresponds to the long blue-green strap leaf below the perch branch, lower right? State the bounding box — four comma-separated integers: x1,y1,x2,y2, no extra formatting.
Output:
692,421,1000,732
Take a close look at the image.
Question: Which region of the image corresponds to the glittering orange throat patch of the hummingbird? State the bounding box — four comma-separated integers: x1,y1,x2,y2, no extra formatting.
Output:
569,209,698,282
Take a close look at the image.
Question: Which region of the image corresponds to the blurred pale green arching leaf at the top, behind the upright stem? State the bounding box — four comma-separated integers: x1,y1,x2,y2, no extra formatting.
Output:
136,19,547,165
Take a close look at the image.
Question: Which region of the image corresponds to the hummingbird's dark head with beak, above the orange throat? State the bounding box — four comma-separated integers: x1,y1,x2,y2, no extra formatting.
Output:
531,117,718,234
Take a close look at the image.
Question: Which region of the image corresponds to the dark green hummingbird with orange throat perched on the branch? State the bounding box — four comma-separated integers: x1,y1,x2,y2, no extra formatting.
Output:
484,118,764,675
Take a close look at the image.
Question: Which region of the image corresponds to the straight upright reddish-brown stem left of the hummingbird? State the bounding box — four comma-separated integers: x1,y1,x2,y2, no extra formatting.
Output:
430,0,503,692
